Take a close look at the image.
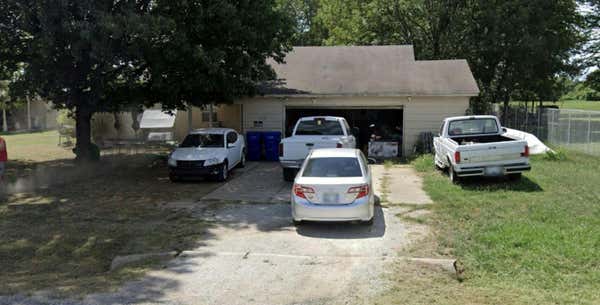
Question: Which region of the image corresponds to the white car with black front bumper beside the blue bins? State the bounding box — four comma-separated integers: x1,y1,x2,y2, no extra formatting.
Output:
168,128,246,181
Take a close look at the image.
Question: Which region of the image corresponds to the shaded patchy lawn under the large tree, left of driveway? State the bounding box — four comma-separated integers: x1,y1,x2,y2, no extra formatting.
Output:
0,132,220,296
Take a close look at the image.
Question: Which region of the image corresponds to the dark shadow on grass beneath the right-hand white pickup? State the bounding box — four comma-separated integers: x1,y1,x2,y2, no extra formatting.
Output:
459,176,544,192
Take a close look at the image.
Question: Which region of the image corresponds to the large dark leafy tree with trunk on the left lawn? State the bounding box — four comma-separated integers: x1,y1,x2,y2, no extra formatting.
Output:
0,0,292,159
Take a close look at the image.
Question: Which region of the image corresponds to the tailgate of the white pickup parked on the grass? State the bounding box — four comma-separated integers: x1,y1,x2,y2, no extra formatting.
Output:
457,140,527,164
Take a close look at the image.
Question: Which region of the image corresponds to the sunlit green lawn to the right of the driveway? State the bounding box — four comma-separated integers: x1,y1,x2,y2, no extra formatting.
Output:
380,152,600,305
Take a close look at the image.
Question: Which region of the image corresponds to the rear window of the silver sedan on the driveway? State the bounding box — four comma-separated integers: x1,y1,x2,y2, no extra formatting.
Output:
302,158,362,178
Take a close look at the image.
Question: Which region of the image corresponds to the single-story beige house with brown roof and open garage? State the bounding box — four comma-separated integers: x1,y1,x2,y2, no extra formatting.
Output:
91,45,479,155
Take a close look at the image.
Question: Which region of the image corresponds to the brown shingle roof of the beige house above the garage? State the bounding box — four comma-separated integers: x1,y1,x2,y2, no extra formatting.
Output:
263,46,479,96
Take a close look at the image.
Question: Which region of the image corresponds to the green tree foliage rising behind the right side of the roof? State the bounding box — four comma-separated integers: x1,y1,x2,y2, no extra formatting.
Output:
316,0,580,116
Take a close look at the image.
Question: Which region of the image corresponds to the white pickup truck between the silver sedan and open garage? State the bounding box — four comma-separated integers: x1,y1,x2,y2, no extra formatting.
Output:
279,116,356,181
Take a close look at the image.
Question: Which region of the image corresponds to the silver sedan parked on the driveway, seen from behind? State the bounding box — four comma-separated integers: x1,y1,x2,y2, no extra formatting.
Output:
292,148,375,224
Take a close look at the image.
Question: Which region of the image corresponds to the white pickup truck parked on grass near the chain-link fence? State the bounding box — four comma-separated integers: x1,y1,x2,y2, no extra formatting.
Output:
433,115,531,182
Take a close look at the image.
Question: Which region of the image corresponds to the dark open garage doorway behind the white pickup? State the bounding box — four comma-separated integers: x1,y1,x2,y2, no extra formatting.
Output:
285,107,404,156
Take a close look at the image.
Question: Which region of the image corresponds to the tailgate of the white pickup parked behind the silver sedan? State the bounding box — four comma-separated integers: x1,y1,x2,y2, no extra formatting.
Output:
281,136,340,160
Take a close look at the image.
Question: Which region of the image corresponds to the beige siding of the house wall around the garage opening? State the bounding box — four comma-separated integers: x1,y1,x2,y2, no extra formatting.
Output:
238,96,469,155
